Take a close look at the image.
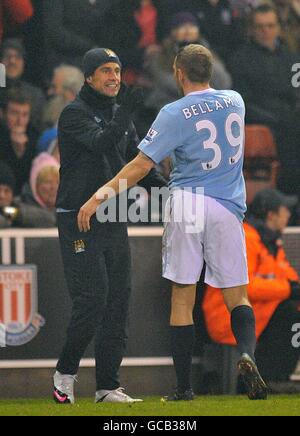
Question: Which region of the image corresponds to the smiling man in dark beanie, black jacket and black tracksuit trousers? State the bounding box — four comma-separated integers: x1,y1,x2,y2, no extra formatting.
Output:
54,49,165,403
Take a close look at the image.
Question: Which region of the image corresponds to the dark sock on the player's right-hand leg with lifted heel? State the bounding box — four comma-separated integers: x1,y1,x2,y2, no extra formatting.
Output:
231,306,256,361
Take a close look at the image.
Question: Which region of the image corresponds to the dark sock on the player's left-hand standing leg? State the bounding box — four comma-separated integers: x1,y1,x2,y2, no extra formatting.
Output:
171,325,195,393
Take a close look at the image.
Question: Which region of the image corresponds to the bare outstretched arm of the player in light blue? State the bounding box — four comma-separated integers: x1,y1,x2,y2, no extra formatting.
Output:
77,152,155,232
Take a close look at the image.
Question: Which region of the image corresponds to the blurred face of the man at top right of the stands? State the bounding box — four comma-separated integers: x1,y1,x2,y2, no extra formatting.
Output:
252,12,280,48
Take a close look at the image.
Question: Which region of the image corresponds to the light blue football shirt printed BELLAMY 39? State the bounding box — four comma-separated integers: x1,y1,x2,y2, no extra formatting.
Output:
139,88,247,220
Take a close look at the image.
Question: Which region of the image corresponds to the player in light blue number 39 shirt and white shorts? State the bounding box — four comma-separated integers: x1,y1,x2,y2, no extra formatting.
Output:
78,45,268,401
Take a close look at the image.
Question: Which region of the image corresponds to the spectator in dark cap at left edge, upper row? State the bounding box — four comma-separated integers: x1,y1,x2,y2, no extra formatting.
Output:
0,39,46,130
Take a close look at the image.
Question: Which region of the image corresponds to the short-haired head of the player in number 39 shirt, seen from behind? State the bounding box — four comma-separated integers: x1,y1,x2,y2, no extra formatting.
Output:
175,44,213,83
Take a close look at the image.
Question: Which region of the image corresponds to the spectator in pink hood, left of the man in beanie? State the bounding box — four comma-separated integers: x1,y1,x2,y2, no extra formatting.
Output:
21,153,59,222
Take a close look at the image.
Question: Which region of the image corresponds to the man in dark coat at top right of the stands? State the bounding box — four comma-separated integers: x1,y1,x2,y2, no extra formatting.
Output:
230,5,300,195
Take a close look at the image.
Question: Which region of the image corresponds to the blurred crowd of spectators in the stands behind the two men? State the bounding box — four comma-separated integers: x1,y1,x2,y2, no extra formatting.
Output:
0,0,300,228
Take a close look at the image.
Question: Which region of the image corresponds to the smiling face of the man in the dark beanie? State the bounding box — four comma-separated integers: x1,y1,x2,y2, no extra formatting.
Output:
88,62,121,97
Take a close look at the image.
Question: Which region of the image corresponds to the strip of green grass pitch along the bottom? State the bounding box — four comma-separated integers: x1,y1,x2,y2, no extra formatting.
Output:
0,395,300,416
